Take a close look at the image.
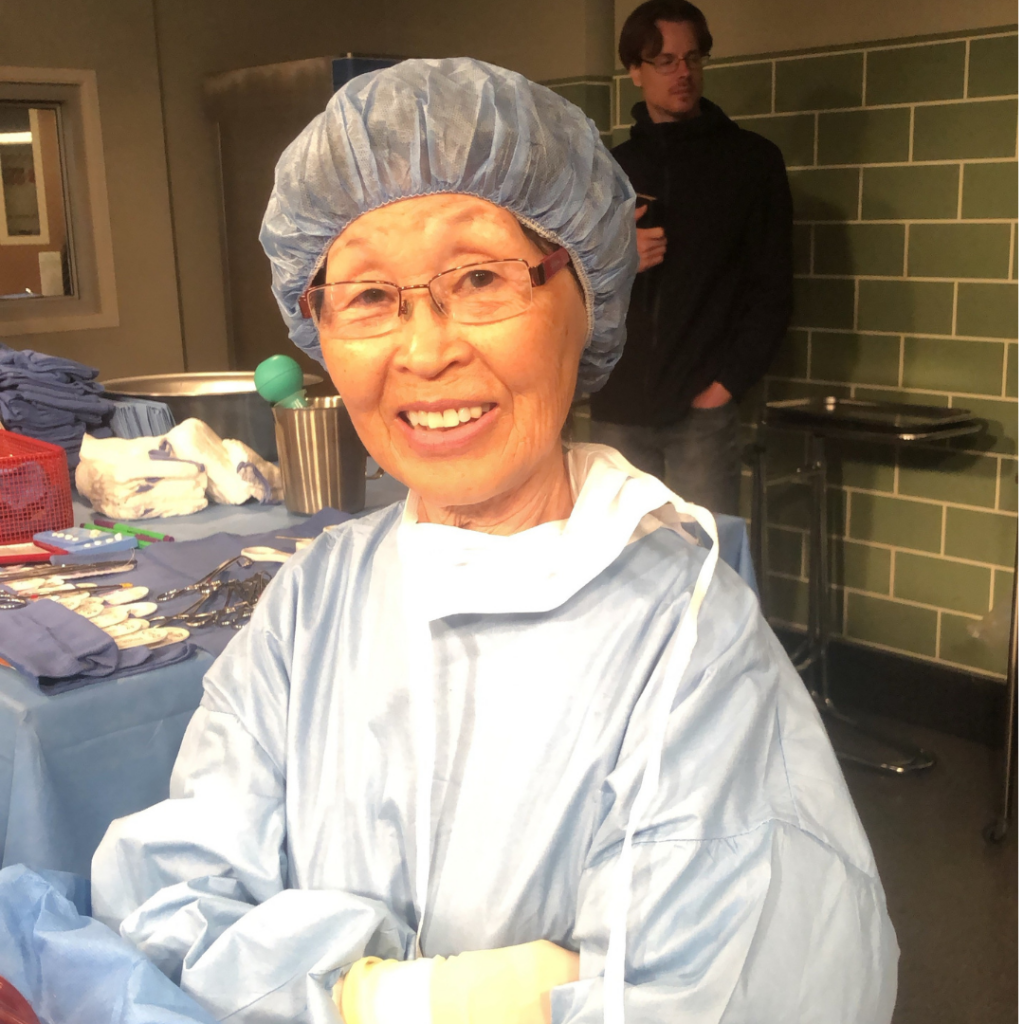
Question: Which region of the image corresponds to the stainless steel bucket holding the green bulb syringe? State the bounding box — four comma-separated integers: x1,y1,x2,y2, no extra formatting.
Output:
273,396,384,515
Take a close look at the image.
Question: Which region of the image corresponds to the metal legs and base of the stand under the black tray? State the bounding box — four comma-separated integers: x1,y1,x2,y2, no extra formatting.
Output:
752,420,936,775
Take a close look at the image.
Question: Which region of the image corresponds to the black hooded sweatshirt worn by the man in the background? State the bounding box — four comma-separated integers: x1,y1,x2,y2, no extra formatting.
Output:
591,99,793,426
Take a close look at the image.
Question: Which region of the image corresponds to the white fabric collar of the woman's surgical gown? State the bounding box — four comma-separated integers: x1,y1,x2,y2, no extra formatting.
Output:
398,444,708,621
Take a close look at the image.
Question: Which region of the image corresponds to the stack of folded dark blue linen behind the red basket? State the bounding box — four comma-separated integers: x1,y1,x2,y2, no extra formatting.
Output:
0,345,115,469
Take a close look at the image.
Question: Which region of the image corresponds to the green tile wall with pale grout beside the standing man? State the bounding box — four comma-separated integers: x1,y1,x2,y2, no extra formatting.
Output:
606,30,1018,677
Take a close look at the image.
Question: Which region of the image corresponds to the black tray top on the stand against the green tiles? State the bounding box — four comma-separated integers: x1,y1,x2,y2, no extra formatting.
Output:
765,396,974,434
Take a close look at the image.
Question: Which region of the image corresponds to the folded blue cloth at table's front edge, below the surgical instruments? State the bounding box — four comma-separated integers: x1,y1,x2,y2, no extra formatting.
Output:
0,600,195,693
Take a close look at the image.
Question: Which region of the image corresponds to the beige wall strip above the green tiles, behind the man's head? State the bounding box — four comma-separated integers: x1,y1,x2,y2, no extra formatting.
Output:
615,0,1017,65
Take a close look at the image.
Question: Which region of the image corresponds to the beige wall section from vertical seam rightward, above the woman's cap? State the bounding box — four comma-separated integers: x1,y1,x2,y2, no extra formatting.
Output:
157,0,612,370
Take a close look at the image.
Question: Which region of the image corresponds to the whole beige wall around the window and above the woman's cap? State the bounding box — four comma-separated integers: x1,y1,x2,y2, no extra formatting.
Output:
0,0,613,376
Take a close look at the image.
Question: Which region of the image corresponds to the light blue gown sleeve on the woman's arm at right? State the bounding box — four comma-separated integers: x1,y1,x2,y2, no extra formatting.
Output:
552,572,898,1024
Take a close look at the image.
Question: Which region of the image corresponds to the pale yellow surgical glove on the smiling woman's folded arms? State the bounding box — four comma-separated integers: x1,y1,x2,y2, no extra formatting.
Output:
333,939,580,1024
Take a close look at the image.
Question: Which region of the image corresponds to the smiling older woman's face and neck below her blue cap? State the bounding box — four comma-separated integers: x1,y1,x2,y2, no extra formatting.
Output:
313,195,588,534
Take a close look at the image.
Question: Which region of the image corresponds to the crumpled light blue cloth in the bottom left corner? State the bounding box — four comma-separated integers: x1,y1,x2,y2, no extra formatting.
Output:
0,864,214,1024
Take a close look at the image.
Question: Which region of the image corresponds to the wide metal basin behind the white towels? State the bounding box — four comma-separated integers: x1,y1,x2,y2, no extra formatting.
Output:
101,373,323,462
